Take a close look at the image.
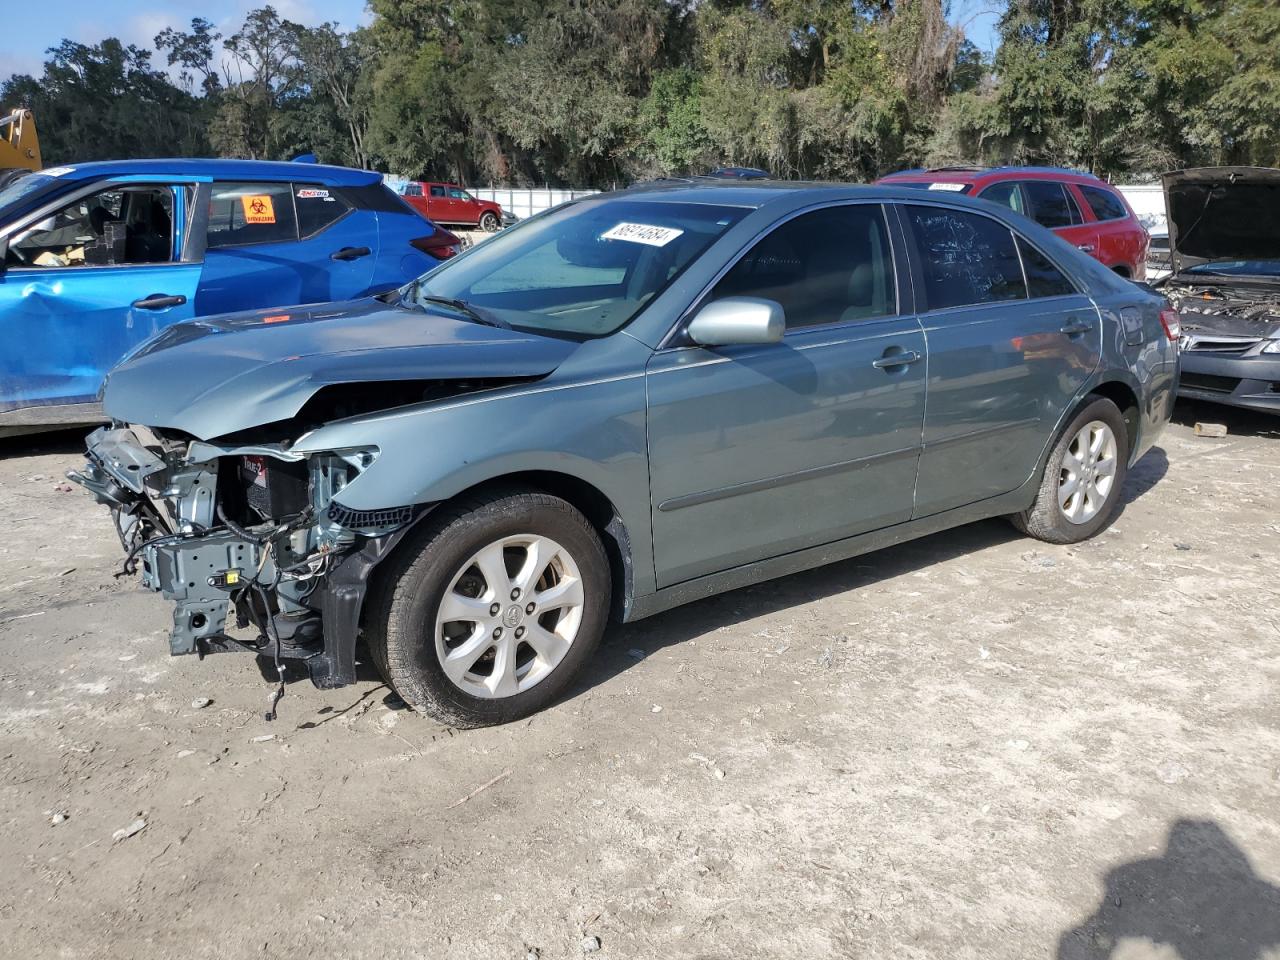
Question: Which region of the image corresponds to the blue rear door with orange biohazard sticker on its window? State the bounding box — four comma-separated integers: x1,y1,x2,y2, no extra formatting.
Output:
196,180,379,315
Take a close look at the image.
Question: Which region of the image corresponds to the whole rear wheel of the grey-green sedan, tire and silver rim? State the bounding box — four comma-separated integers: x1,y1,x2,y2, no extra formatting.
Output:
1010,397,1129,544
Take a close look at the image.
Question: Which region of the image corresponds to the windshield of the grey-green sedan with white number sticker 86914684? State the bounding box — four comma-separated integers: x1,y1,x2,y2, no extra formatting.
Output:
406,200,750,339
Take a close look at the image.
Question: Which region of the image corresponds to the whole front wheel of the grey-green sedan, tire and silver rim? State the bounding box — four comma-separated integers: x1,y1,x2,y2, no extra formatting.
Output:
367,492,611,727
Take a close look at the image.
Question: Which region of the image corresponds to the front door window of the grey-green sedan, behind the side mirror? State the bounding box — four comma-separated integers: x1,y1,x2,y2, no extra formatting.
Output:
712,204,897,329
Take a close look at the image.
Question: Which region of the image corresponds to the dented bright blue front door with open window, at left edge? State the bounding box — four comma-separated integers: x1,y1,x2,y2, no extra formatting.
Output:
0,178,200,419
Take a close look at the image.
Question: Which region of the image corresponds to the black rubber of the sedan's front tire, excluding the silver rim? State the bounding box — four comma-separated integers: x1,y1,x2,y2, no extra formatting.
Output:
366,490,612,727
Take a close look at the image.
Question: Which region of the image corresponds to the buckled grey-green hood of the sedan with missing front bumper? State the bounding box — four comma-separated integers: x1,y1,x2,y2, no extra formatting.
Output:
102,298,577,440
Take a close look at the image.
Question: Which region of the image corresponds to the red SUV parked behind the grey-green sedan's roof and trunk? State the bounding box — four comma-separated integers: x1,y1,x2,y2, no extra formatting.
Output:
878,166,1151,280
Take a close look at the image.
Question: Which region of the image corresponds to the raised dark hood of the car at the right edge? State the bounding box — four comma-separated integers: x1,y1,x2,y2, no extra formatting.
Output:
1161,166,1280,274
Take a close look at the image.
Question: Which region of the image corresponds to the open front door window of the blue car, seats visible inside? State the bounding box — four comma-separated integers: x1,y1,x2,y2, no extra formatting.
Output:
5,187,175,269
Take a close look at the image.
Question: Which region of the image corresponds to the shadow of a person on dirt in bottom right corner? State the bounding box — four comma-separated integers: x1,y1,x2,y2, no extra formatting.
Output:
1057,820,1280,960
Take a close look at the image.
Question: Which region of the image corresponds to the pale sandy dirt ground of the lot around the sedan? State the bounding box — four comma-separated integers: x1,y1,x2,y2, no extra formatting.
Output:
0,407,1280,960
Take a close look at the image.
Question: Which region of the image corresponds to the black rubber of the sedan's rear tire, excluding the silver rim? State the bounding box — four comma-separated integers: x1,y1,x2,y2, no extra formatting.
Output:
1010,397,1129,544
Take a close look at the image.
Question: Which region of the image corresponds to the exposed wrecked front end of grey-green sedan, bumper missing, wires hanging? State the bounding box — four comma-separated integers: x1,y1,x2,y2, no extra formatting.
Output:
68,424,425,687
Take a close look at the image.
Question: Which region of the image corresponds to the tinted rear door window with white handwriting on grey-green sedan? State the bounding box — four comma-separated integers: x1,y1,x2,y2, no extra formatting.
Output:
902,205,1027,310
